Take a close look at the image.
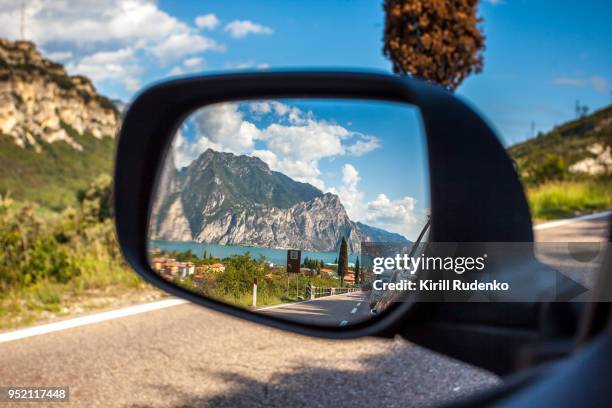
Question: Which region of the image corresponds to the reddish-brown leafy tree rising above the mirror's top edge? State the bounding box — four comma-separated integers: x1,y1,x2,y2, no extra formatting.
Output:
383,0,485,90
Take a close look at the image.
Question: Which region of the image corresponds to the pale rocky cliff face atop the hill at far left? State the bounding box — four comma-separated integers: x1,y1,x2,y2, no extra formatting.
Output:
0,39,120,152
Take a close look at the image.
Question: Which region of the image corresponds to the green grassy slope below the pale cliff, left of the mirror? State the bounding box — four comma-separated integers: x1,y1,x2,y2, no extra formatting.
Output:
0,125,115,210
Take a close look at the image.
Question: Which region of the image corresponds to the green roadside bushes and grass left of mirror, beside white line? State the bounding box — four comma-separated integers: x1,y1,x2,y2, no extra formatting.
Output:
0,176,161,330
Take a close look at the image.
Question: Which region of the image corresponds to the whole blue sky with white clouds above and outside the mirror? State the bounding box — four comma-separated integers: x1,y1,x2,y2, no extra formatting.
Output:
0,0,612,144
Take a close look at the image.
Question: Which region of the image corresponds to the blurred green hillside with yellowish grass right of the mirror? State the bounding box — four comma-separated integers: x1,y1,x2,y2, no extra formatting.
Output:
508,106,612,220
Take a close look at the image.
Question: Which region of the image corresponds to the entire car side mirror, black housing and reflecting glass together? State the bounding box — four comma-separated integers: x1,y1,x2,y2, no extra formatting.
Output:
115,72,584,356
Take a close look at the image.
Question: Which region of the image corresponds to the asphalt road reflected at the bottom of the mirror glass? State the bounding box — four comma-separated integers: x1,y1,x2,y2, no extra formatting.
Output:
258,292,370,326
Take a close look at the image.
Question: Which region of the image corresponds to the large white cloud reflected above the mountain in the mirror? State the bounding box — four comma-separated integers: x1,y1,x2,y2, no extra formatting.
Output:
172,101,380,190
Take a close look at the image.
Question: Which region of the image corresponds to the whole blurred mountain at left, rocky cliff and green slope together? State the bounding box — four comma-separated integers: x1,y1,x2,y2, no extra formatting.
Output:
0,39,120,208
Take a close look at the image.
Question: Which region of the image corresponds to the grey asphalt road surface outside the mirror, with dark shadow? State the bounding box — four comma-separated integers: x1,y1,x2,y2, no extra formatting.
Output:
0,215,605,407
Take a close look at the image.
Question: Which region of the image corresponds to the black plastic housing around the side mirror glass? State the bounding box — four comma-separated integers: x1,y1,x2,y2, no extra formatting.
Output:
114,72,533,338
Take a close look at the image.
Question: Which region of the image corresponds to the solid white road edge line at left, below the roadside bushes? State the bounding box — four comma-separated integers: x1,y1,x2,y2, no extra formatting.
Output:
0,298,189,343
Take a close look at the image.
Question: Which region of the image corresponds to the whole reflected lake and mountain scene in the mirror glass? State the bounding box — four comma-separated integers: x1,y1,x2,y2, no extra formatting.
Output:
149,99,429,326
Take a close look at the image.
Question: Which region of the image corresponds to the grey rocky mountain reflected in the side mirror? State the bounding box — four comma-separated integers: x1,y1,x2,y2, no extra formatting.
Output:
151,149,408,252
